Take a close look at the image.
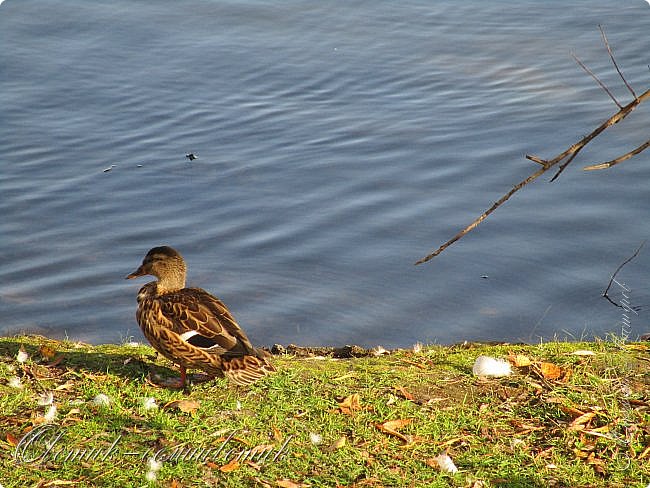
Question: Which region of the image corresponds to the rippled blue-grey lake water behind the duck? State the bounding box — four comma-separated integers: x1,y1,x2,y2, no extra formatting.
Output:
0,0,650,347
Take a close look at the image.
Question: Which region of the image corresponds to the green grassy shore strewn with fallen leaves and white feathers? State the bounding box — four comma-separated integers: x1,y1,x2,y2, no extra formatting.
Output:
0,337,650,488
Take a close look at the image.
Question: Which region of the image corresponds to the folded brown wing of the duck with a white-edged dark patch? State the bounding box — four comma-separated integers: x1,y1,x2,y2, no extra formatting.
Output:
156,288,255,355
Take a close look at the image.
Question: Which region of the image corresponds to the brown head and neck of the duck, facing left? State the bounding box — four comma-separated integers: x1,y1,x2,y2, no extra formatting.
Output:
126,246,186,293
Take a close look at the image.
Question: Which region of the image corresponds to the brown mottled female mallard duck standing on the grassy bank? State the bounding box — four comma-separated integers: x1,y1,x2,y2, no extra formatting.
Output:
126,246,275,387
